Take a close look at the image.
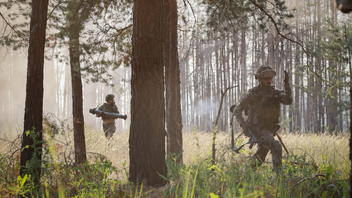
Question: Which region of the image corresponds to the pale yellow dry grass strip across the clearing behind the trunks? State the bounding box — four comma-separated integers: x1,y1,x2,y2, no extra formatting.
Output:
0,128,350,179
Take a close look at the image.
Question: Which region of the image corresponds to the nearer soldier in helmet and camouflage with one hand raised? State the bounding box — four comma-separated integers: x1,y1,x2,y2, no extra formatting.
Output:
234,66,292,174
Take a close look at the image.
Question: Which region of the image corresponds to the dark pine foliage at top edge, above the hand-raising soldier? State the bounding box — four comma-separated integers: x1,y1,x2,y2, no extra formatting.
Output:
203,0,293,36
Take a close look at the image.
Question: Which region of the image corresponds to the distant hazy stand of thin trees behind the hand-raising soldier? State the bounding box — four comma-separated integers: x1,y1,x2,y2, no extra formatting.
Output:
180,0,351,133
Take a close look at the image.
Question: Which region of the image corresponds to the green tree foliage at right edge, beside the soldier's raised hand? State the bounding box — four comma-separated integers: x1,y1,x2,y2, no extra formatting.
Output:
297,19,352,120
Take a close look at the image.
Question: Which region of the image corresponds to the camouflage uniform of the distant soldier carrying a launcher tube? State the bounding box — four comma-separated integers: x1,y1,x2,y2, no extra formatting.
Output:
98,103,119,138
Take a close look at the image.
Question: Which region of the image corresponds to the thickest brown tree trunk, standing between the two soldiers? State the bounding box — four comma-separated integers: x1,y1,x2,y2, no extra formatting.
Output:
129,0,167,186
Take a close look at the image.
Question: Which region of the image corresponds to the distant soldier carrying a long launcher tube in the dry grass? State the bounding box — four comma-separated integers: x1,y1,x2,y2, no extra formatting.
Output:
97,94,119,139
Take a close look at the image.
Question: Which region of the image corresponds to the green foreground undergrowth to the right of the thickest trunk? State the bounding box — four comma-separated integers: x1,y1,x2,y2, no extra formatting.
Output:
164,139,348,197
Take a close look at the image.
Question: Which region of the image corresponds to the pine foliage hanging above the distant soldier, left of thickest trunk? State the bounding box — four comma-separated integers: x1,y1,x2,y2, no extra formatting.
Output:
54,0,132,84
